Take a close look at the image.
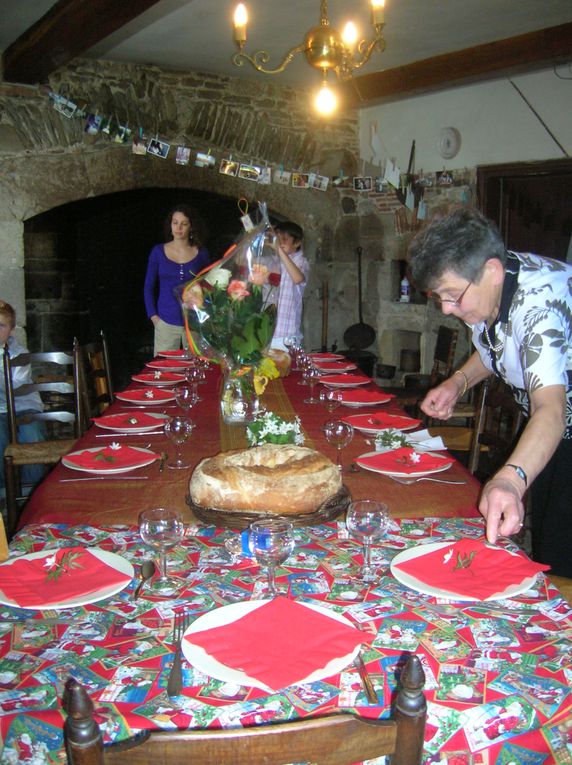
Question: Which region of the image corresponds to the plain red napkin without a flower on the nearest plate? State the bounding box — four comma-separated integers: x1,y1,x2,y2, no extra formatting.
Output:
185,597,367,690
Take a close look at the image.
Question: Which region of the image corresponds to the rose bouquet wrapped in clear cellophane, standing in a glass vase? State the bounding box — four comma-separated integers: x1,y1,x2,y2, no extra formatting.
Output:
176,204,280,423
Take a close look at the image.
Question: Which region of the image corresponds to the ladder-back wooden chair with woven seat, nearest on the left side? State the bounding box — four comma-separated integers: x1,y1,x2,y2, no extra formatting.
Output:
4,341,83,537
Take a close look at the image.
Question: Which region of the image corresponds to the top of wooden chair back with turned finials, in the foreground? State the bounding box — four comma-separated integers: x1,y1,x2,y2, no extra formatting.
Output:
62,655,427,765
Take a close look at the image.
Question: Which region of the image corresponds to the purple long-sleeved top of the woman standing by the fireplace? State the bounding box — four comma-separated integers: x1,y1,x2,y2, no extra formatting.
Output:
143,244,210,327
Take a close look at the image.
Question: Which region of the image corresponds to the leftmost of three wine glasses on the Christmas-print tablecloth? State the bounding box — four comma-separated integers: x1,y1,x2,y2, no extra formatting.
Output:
139,507,185,595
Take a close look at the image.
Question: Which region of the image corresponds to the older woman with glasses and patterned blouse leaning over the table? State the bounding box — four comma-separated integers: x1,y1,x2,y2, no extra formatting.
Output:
409,207,572,577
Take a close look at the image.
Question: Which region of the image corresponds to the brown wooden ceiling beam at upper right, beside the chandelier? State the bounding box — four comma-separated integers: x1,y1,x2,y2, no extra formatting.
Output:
338,22,572,109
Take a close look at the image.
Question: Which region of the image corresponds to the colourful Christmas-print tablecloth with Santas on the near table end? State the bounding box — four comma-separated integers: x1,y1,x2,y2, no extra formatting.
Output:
0,518,572,765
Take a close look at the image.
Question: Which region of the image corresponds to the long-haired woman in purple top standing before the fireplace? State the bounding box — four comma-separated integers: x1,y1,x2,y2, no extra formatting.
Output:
144,204,210,355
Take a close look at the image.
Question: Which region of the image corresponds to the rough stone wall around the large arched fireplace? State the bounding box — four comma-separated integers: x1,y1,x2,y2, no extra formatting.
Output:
0,60,469,370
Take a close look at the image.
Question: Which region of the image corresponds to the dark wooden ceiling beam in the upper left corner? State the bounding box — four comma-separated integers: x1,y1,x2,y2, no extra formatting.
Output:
2,0,163,84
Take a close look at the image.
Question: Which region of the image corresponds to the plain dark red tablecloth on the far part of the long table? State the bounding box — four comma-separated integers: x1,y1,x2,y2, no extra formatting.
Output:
19,366,480,527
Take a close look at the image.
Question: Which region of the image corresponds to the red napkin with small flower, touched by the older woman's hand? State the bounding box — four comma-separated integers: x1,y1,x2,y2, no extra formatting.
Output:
396,539,550,600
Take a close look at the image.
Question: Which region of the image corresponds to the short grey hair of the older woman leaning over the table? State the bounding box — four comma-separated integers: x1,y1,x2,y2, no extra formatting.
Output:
408,205,507,291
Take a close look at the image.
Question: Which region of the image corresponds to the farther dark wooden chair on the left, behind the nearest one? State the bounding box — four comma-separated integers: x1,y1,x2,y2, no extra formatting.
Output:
80,330,113,430
